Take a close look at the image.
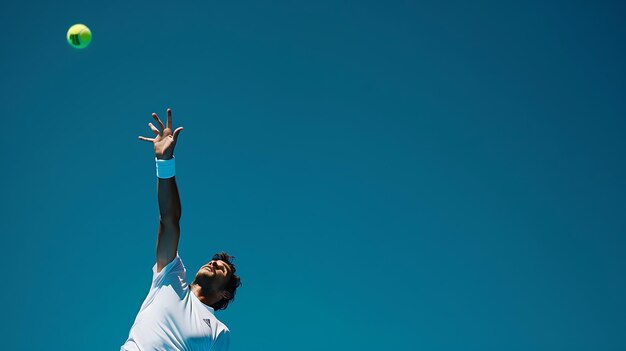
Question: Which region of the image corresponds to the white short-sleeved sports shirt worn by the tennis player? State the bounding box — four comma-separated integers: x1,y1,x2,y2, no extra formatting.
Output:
120,253,230,351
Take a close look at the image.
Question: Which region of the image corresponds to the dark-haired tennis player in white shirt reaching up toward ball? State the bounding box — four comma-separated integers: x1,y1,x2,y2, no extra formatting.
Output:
121,109,241,351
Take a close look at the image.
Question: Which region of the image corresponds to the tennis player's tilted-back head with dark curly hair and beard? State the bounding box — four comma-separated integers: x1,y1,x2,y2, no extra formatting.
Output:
192,252,241,311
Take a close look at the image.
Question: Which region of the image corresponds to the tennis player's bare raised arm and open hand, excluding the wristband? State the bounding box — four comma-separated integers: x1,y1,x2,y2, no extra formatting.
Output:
139,108,183,272
